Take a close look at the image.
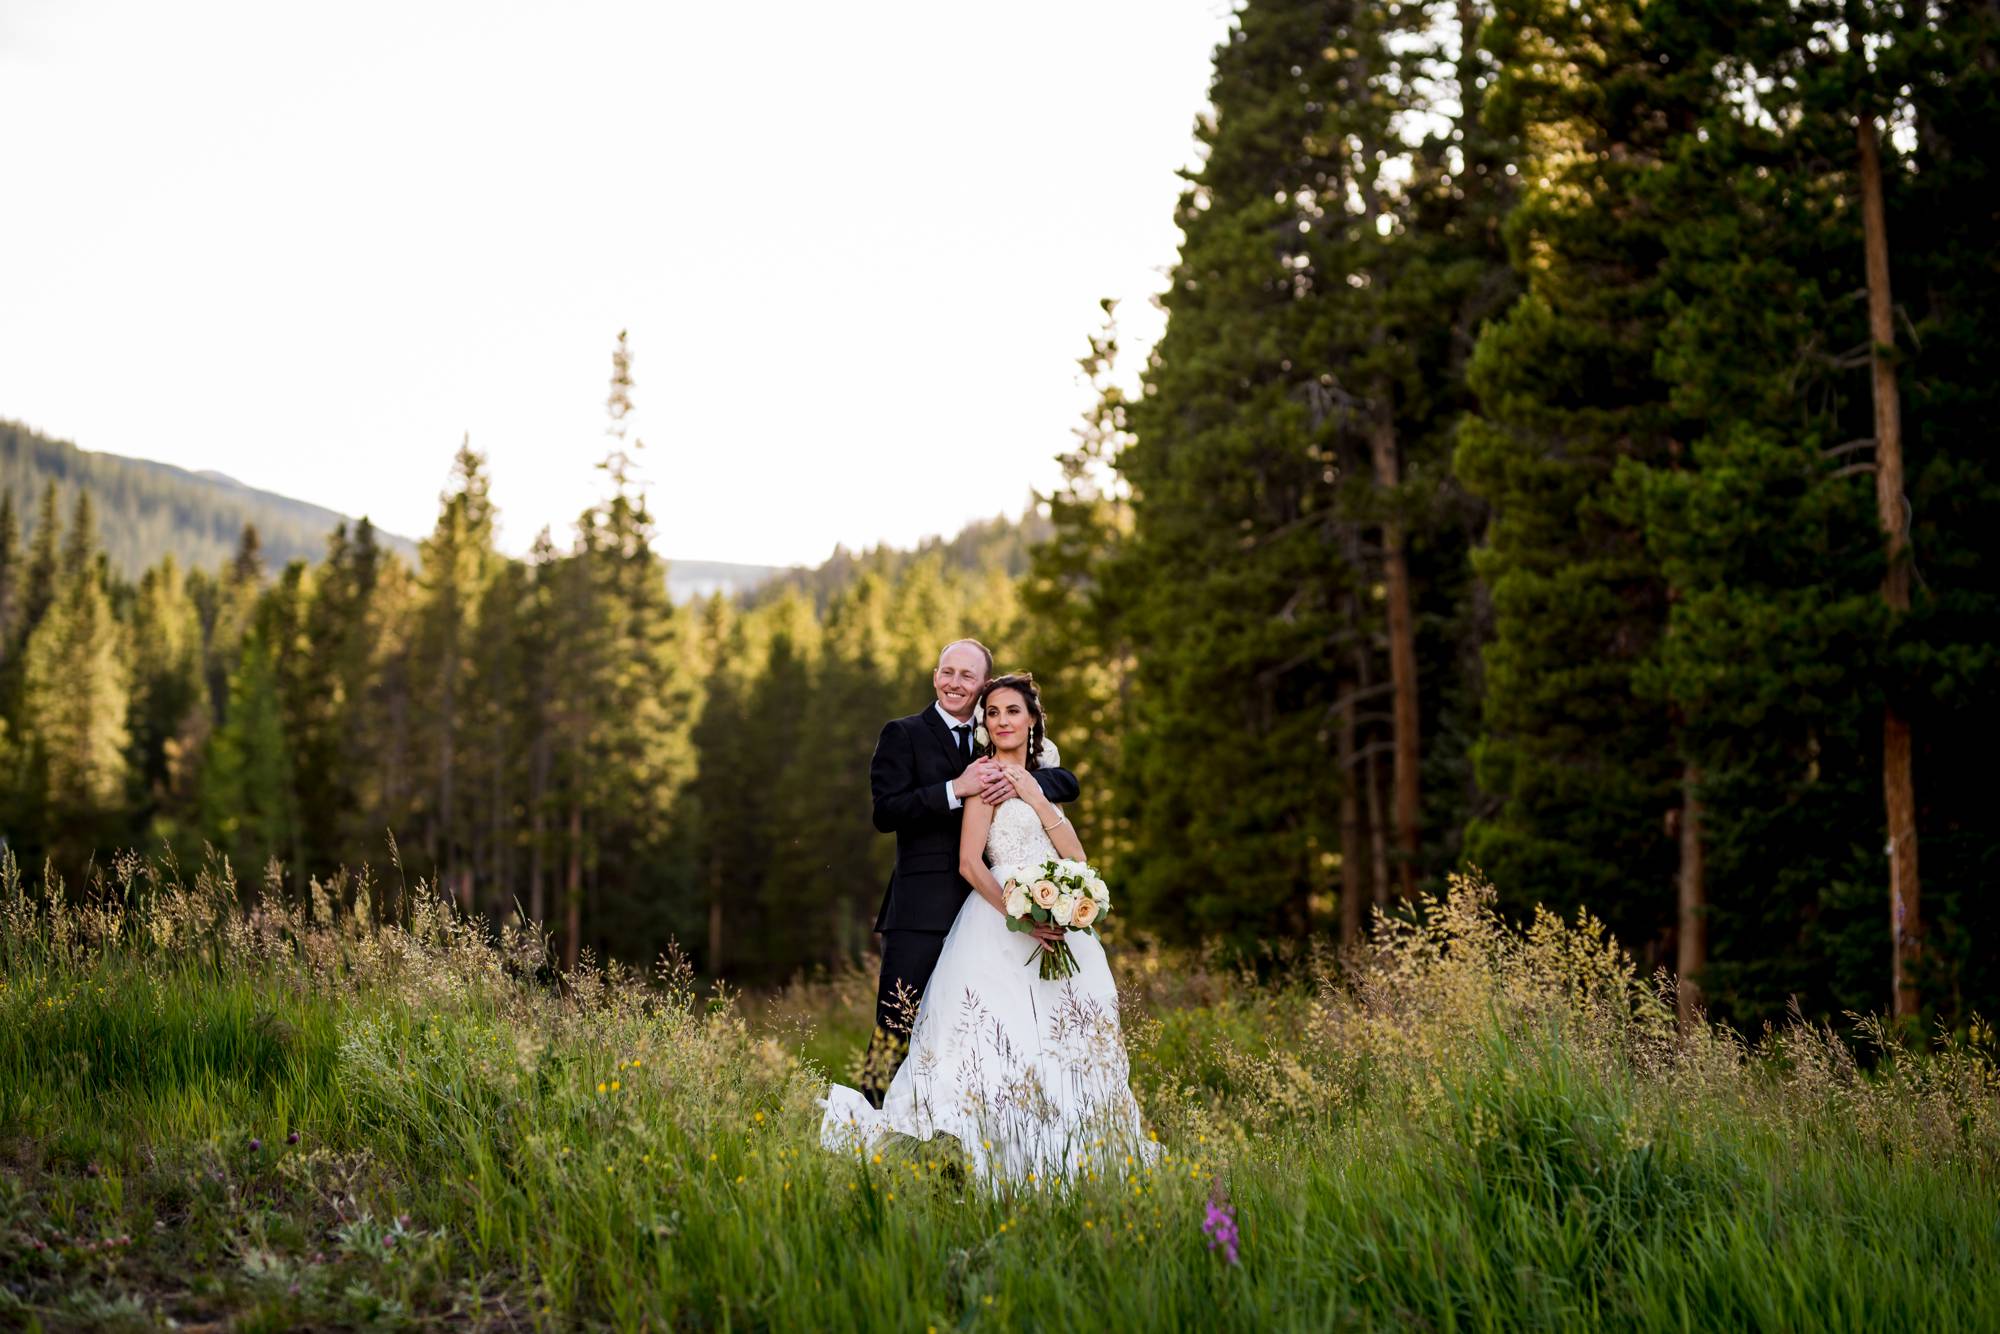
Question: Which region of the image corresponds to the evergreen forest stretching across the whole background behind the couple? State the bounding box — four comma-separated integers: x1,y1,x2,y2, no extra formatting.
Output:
0,0,2000,1028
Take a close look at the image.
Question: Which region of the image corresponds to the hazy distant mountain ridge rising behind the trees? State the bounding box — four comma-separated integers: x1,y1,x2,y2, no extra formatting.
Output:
0,418,788,602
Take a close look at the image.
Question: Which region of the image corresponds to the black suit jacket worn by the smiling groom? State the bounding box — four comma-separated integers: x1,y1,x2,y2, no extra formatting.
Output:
868,708,1082,932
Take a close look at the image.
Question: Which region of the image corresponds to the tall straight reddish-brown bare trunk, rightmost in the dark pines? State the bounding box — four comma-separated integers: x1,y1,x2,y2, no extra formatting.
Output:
1856,114,1922,1018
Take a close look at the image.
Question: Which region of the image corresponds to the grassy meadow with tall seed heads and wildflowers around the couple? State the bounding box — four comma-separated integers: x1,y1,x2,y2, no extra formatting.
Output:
0,858,2000,1330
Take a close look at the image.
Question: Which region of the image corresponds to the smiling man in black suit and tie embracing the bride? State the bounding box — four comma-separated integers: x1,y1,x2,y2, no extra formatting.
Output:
862,640,1080,1106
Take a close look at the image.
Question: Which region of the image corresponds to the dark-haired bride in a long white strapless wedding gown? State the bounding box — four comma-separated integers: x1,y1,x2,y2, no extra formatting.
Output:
820,672,1158,1180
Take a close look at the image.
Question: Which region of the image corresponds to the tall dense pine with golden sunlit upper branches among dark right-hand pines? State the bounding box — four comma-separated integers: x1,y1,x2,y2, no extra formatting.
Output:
1456,0,1708,948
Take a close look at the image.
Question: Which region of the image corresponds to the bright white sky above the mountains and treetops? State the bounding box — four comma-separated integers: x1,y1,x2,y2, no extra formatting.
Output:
0,0,1230,564
